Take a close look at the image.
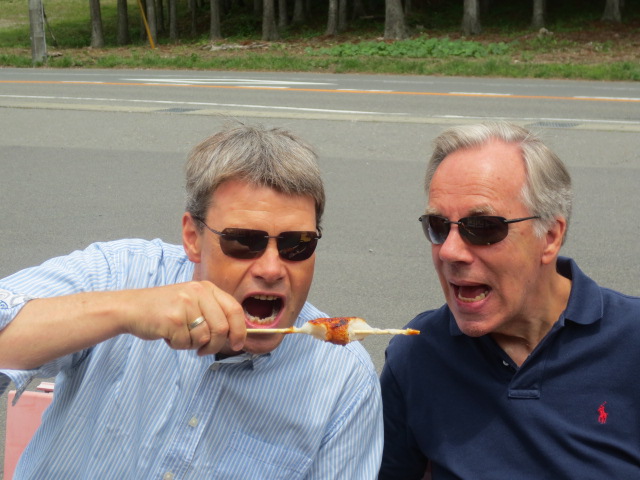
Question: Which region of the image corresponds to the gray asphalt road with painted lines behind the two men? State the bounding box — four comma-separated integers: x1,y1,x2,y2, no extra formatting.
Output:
0,69,640,476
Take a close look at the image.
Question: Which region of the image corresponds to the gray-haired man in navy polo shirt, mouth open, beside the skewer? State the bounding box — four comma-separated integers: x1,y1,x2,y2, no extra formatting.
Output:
378,122,640,480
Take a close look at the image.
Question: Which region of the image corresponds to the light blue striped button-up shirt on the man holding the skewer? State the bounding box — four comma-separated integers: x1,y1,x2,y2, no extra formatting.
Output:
0,240,382,480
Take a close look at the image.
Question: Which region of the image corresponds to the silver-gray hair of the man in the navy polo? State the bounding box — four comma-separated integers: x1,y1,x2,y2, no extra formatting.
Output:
425,122,573,241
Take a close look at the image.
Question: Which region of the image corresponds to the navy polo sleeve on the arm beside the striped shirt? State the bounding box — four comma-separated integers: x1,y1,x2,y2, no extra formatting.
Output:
378,363,428,480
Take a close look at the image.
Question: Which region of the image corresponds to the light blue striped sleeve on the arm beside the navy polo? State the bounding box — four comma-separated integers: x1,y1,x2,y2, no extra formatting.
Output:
306,348,384,480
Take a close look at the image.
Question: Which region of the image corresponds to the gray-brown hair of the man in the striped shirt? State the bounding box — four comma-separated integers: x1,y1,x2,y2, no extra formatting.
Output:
185,124,325,231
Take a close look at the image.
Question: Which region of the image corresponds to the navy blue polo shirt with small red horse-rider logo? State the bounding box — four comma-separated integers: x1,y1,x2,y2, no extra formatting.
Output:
379,258,640,480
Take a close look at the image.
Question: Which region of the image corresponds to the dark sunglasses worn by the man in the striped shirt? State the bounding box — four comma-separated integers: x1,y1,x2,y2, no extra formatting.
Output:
193,217,322,262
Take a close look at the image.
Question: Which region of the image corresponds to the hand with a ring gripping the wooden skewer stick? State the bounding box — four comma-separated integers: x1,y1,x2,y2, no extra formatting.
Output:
126,281,246,355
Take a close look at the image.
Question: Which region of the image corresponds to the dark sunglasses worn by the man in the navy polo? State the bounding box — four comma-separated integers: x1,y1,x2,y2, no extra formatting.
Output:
418,215,540,245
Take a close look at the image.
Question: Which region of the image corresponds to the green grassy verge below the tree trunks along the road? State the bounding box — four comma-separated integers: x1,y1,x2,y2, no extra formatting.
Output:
0,0,640,81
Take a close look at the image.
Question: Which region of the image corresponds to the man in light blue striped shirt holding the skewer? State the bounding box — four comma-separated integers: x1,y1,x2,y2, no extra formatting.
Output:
0,125,382,480
